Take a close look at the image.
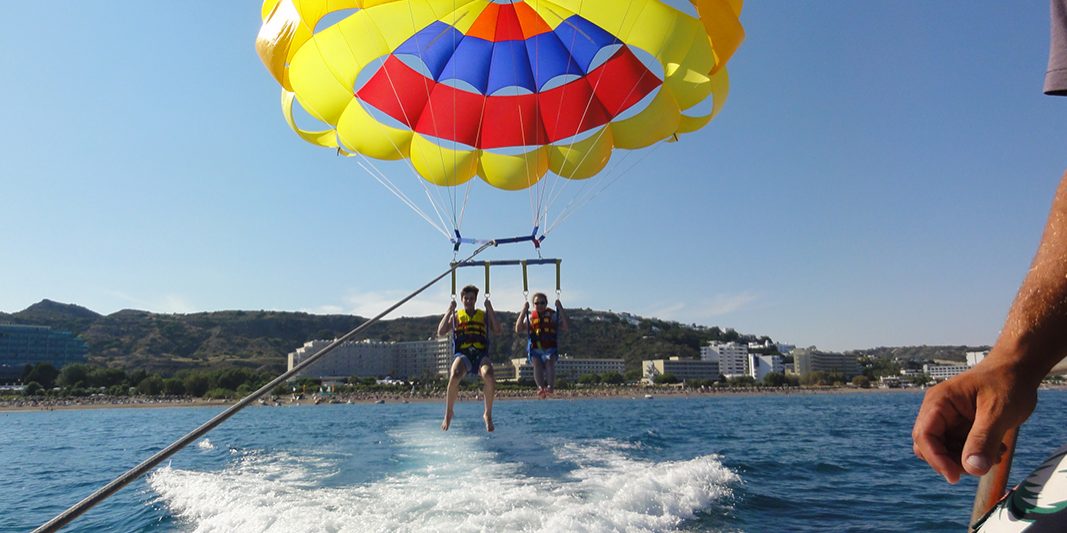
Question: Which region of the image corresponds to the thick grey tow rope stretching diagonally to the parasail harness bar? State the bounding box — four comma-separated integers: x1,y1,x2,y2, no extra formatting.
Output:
33,242,493,533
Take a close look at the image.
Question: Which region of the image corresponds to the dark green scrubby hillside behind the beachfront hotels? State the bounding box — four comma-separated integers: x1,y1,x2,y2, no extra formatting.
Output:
0,300,766,373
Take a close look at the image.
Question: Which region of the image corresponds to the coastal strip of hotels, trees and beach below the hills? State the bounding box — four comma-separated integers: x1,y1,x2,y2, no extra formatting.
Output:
0,313,1015,408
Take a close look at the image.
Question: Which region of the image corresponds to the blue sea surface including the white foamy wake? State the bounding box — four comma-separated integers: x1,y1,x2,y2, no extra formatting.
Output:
0,391,1067,533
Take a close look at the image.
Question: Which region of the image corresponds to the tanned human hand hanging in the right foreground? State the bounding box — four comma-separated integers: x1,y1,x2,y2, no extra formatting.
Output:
911,358,1040,484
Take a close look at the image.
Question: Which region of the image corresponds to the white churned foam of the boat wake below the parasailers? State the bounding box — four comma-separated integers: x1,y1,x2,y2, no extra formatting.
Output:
148,430,739,532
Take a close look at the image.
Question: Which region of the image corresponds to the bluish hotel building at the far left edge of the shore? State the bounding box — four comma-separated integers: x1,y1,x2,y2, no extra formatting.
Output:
0,324,89,382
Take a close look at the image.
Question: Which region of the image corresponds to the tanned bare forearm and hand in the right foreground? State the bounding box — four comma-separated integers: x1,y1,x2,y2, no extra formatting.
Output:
911,174,1067,483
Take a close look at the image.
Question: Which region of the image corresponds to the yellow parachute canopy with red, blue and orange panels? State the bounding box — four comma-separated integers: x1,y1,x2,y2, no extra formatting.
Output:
256,0,744,190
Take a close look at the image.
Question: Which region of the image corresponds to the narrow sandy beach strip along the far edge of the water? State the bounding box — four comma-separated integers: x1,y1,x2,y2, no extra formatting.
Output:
0,387,923,414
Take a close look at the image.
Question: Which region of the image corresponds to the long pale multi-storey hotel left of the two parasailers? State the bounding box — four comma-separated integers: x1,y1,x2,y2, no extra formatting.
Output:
289,337,452,379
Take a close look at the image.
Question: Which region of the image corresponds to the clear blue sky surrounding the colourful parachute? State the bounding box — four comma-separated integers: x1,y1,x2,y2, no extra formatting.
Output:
0,0,1067,350
